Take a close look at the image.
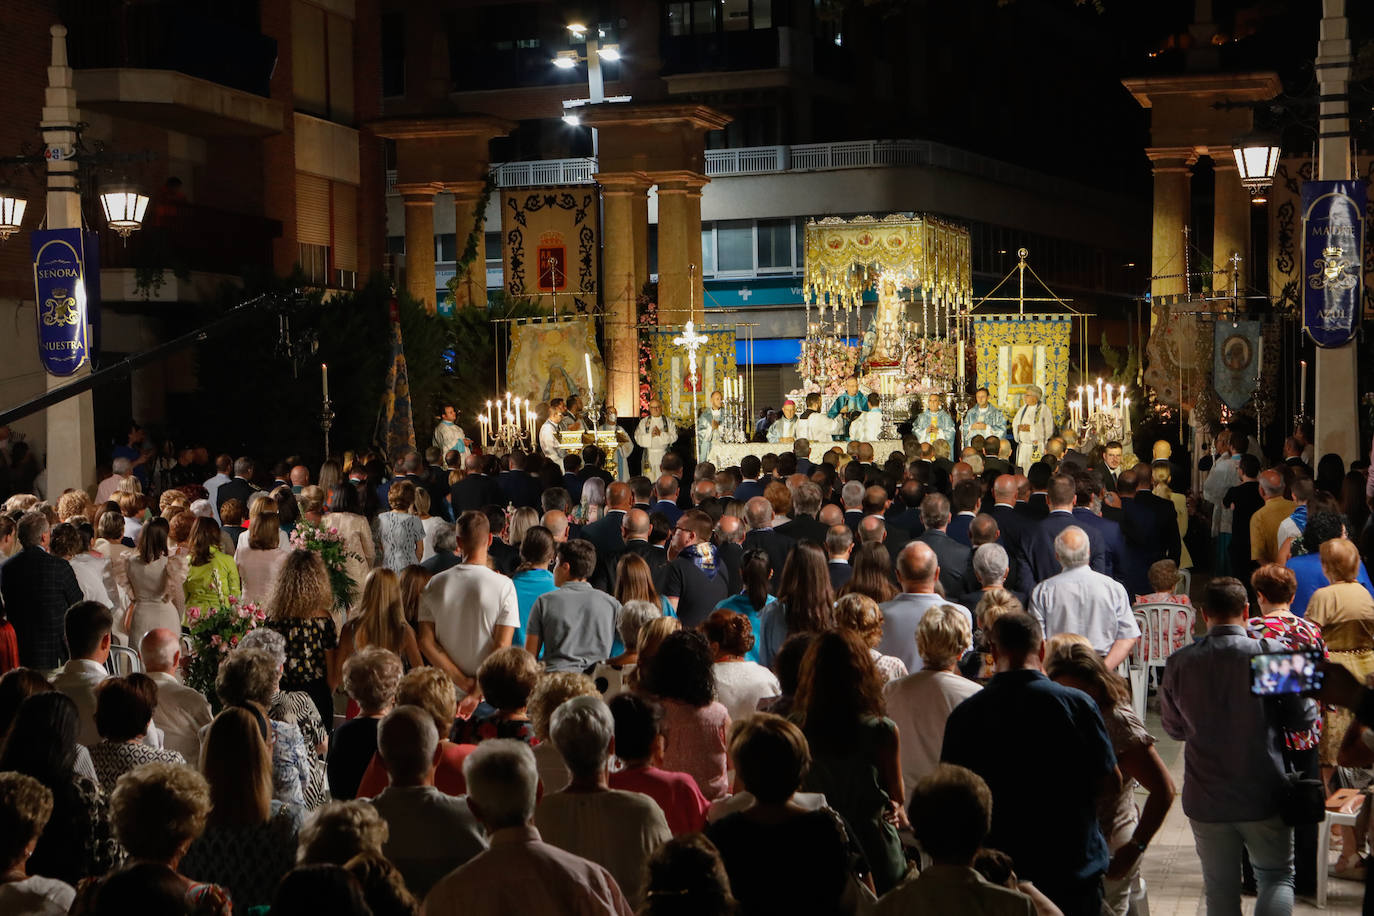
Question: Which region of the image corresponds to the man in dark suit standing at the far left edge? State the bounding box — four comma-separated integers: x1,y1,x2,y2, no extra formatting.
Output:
0,516,82,672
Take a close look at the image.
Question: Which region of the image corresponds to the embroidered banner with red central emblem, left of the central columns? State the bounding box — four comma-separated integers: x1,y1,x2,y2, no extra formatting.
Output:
502,184,600,313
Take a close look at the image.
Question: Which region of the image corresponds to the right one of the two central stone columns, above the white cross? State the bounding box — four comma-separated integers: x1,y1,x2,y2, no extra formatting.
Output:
651,170,709,325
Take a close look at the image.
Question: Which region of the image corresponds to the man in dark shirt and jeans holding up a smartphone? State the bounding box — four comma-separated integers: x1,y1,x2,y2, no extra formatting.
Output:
1160,577,1316,916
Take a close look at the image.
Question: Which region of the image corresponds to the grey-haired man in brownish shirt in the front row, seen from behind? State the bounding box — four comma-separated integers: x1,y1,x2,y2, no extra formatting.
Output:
425,737,632,916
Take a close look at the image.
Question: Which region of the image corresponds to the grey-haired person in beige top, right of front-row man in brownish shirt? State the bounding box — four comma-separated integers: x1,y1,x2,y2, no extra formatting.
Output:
534,696,672,904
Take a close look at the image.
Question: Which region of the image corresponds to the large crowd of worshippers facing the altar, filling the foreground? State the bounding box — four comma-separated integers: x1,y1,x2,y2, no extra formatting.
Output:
0,402,1374,916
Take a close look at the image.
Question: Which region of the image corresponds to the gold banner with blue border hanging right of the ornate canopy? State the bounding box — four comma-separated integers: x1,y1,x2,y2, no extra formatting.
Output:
973,314,1073,423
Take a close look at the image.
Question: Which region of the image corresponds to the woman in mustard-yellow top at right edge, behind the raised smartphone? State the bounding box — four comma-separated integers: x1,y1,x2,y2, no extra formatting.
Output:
1305,537,1374,768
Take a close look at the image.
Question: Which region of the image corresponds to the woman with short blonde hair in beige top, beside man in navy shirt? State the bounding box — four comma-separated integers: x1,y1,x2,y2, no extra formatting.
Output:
882,604,982,786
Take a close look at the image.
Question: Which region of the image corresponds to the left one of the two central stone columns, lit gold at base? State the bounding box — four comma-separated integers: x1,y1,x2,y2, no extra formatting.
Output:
594,172,650,416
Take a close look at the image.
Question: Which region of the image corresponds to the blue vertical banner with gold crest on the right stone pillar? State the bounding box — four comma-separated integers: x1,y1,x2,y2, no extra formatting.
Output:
1303,181,1367,347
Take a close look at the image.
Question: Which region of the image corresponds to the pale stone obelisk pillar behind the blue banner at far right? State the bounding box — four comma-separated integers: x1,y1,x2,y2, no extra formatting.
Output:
1312,0,1360,460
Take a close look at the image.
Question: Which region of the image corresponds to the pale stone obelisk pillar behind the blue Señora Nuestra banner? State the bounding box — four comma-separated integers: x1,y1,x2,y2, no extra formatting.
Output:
34,25,96,500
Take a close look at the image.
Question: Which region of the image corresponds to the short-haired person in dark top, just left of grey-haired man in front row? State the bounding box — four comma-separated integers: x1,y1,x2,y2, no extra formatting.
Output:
371,706,486,900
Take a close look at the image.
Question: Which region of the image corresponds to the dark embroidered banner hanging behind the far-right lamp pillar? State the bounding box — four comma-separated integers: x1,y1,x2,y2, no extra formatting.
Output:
1268,155,1374,317
